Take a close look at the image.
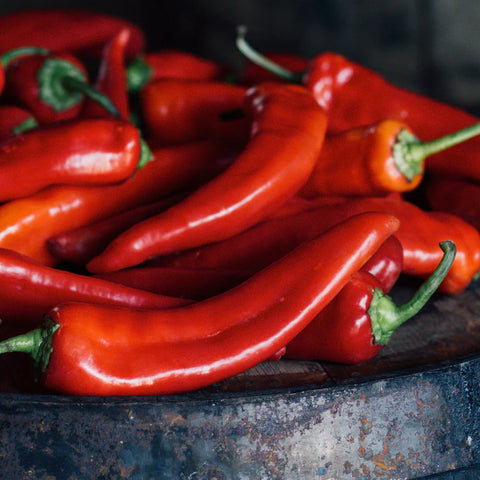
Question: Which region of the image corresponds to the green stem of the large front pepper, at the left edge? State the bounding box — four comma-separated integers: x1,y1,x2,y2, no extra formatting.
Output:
0,317,60,374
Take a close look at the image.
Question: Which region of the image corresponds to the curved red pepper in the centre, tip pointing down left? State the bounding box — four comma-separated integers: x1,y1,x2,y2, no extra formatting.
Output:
88,80,327,273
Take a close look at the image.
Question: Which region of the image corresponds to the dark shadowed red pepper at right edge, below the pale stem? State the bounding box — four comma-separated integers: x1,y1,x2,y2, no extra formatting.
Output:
426,175,480,230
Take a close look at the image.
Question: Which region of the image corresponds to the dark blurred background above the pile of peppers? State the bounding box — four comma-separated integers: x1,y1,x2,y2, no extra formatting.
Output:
0,0,480,114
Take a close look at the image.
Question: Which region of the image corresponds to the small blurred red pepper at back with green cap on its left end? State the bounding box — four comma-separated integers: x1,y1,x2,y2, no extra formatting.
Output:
127,50,228,92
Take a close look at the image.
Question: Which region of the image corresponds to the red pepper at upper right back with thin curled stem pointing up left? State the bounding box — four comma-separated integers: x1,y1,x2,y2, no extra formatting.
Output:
237,29,480,180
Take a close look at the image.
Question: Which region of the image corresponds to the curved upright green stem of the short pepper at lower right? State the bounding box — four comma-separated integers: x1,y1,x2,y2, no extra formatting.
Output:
368,240,457,345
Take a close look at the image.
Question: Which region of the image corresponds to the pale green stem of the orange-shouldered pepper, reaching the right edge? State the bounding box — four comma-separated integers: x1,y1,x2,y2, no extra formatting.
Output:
393,122,480,181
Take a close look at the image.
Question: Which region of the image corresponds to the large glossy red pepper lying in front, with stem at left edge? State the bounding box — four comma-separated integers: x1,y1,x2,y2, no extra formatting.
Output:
0,213,399,395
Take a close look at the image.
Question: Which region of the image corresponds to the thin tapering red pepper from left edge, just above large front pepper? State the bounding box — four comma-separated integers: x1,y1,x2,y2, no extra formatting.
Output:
0,248,189,328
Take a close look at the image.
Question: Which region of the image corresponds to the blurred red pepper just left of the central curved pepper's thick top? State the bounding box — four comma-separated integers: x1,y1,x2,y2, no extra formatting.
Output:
140,79,250,145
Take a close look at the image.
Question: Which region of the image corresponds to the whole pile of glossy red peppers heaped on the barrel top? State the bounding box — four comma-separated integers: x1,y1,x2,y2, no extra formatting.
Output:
0,10,480,395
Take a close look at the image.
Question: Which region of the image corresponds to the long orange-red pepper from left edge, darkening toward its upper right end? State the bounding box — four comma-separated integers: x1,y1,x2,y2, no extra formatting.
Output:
0,141,236,265
